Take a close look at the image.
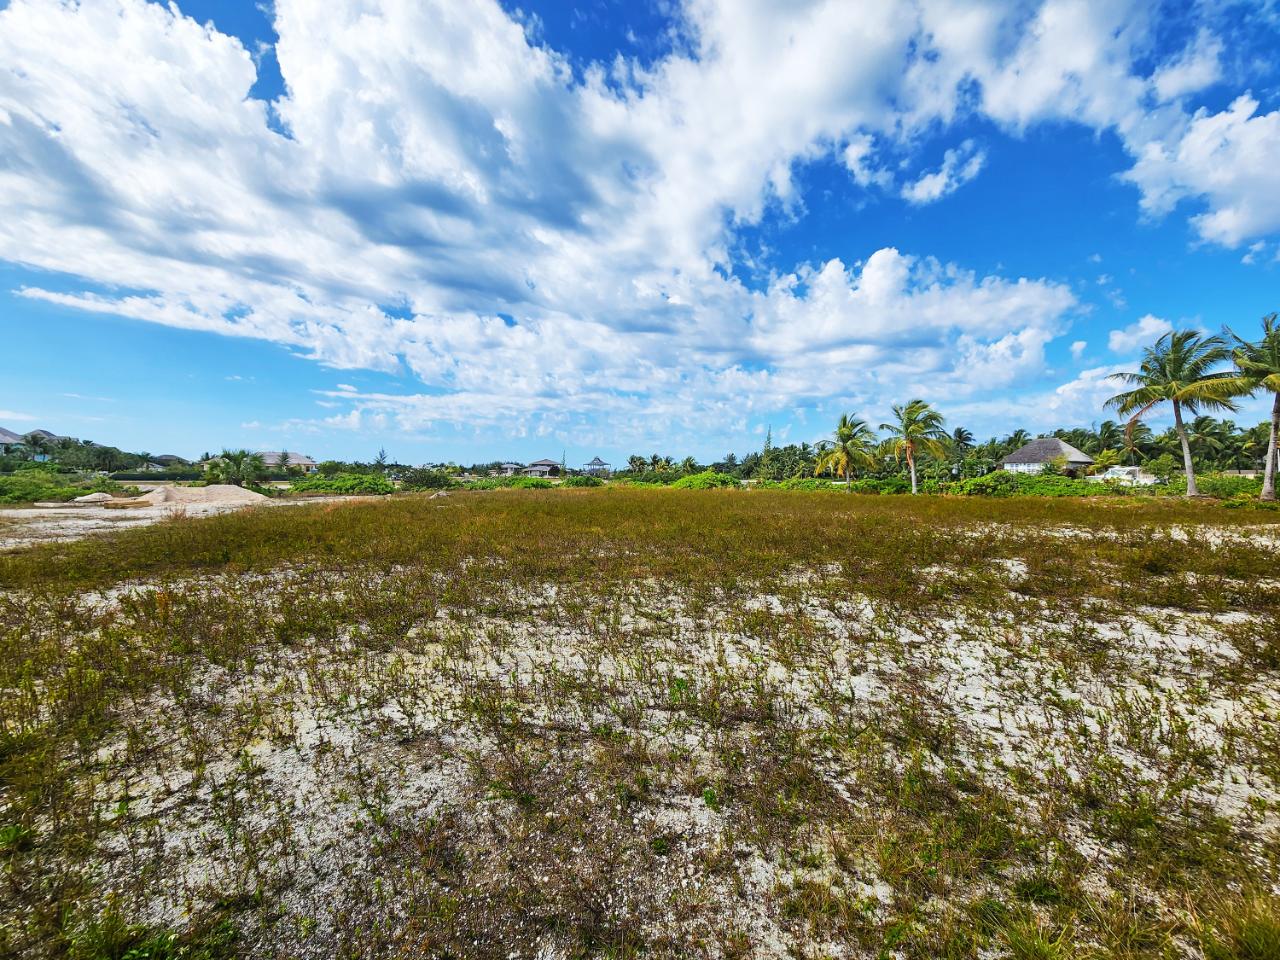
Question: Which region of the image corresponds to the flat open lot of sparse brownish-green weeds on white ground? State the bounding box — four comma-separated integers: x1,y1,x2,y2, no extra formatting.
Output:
0,489,1280,960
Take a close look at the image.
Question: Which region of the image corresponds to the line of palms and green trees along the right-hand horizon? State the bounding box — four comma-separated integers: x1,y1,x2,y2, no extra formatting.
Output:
623,314,1280,500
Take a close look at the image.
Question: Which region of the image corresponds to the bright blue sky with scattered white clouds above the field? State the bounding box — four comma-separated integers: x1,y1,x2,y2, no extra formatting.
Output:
0,0,1280,462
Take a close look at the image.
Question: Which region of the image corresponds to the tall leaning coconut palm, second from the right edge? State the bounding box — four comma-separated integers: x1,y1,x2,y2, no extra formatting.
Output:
1107,330,1240,497
